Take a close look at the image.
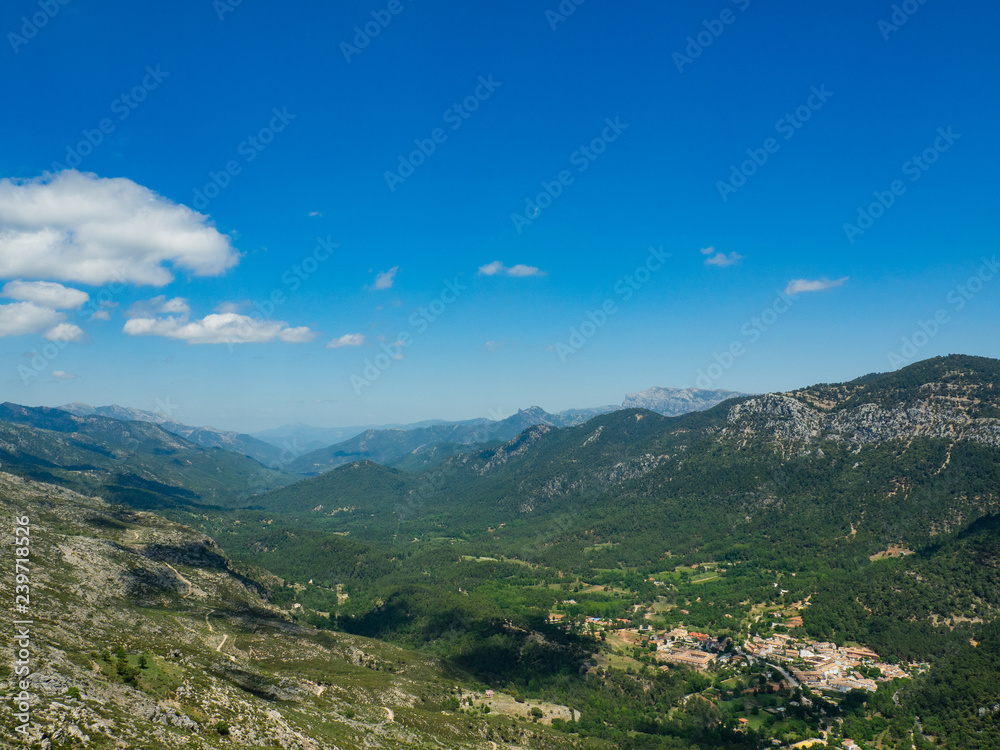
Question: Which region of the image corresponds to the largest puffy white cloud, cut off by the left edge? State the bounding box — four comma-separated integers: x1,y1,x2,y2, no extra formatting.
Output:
0,170,239,286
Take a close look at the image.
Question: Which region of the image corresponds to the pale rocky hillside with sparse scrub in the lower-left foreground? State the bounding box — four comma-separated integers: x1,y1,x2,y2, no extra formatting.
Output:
0,473,584,750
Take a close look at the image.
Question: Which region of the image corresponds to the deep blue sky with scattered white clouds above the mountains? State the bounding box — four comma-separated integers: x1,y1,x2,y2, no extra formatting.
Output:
0,0,1000,430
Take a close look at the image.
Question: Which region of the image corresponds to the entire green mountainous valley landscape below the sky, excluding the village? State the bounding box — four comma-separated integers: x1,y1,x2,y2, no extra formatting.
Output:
0,362,1000,750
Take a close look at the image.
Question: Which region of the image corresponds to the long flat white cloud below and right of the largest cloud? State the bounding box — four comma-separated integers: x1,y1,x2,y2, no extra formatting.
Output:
122,313,316,344
